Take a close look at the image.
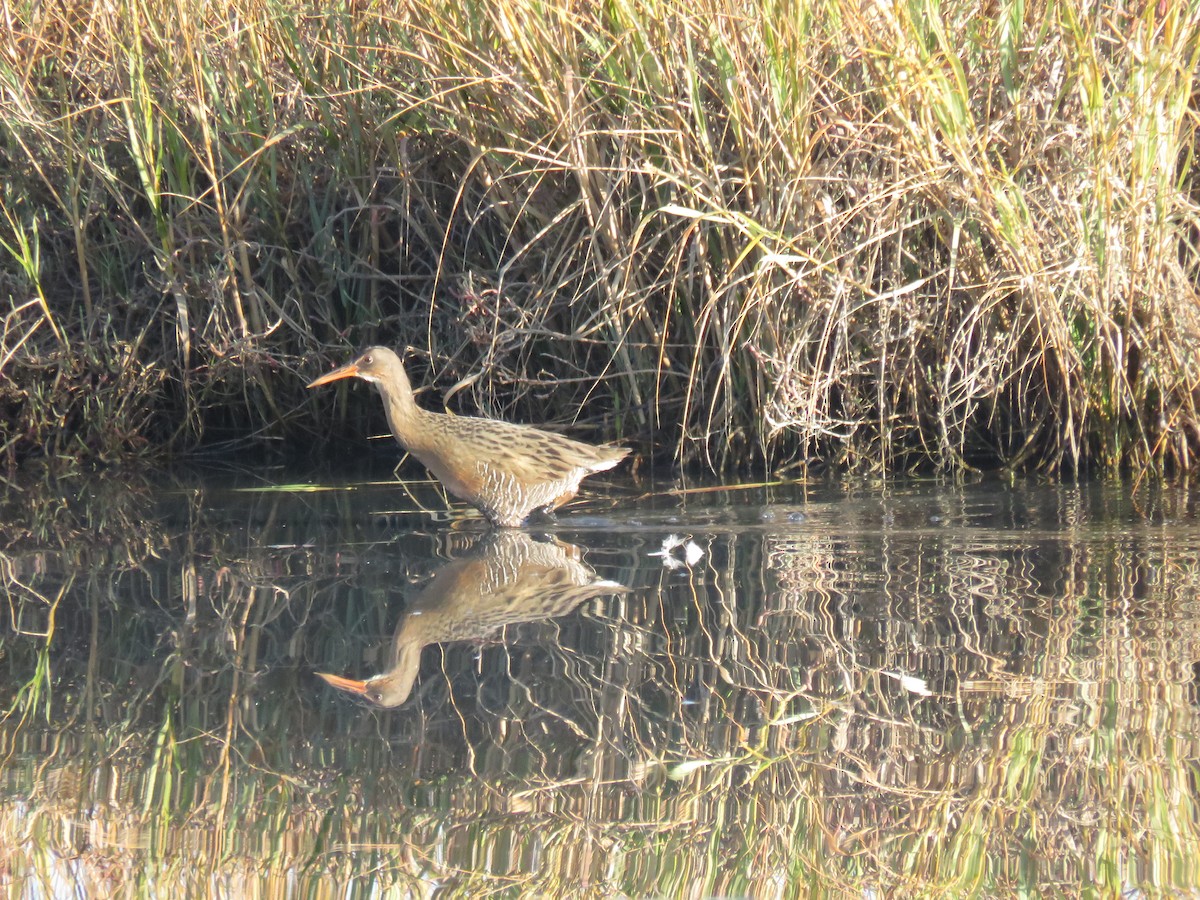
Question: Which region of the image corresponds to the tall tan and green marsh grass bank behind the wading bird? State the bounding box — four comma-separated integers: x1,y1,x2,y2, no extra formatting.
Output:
0,0,1200,472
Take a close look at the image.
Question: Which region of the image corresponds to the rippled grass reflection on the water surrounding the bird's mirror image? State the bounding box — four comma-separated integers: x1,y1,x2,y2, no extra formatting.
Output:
0,480,1200,896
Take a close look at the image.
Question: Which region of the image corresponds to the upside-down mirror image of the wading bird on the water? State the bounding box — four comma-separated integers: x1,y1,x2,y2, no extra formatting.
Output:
317,532,629,707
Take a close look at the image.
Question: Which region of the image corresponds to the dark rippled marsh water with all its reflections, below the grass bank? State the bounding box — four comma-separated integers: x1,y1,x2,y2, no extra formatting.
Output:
0,470,1200,898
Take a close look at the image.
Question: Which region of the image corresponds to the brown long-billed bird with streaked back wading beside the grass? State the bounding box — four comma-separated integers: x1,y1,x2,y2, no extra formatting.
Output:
308,347,629,527
